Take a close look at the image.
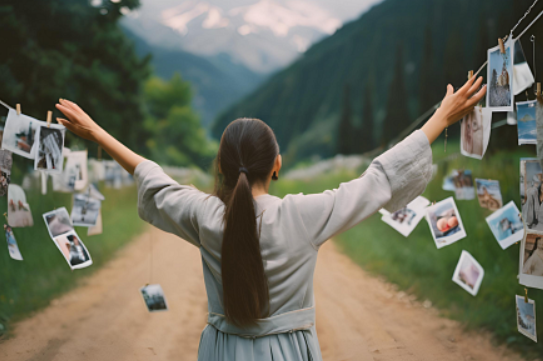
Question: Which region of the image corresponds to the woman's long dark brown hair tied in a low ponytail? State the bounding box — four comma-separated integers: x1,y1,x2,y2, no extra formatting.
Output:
215,119,279,326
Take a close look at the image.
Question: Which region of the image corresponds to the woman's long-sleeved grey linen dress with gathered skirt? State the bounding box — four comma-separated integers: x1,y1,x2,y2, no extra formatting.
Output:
134,130,432,361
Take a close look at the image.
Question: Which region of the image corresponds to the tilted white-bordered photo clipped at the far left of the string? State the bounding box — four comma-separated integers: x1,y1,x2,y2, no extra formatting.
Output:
2,109,44,159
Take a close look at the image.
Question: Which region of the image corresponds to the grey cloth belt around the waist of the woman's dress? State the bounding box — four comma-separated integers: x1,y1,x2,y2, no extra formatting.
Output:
207,307,315,338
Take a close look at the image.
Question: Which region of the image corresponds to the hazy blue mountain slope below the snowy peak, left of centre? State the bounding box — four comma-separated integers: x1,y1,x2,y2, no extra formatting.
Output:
124,28,265,126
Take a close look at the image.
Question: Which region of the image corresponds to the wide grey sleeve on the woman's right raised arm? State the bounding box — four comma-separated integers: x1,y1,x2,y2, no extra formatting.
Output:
292,130,432,248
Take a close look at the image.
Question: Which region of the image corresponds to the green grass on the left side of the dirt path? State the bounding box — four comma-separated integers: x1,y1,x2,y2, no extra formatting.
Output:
0,180,144,334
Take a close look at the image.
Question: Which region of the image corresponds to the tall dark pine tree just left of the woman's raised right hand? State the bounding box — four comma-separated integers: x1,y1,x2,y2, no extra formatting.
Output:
381,45,411,145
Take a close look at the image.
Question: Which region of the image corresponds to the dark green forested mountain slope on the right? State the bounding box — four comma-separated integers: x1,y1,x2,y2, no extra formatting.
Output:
212,0,541,162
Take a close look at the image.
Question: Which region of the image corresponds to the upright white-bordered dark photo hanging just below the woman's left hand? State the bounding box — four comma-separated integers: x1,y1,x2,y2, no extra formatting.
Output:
34,124,66,173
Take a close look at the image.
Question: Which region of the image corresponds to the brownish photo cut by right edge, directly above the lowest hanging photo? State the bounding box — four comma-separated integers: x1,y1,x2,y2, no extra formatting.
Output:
519,231,543,289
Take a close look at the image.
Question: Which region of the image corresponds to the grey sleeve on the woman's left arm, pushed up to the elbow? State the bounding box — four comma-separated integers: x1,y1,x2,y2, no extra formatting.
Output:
134,160,209,247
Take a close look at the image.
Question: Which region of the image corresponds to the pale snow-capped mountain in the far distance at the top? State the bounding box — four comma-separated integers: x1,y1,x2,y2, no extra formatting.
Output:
123,0,380,73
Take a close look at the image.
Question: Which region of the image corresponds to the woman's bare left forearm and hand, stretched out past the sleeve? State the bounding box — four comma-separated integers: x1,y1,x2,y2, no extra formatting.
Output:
56,99,145,174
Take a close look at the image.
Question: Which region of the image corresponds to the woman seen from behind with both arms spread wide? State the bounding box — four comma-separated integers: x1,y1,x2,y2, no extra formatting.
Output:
57,74,486,361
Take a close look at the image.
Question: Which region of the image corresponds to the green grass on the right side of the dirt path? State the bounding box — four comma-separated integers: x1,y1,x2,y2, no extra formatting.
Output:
271,142,543,357
